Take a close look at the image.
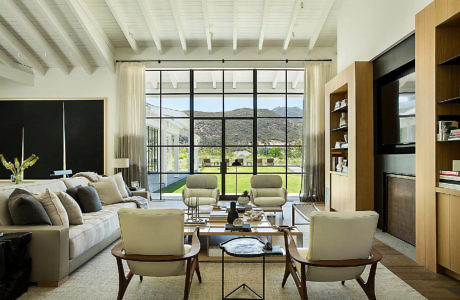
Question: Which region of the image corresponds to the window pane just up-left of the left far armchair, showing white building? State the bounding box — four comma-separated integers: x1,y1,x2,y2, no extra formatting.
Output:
160,147,190,173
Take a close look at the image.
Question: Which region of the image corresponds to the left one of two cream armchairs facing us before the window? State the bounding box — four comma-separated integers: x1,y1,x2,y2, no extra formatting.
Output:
182,174,219,206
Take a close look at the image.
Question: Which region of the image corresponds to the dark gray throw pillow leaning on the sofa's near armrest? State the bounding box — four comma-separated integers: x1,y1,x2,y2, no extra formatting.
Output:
8,189,51,225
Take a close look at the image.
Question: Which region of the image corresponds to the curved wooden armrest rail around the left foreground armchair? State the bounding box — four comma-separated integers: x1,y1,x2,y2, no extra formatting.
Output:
112,227,201,262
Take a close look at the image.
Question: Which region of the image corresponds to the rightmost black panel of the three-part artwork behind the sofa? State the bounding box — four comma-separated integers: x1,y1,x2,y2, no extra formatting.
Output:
65,100,104,174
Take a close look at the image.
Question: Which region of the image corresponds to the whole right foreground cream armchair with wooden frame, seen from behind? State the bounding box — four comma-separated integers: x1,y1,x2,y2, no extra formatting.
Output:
282,211,382,299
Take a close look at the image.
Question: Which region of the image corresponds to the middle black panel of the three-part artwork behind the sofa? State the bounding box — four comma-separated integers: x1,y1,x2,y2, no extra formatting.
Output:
22,100,63,179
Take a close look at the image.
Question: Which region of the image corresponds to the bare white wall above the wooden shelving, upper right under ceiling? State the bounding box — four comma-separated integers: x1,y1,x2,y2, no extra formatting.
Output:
337,0,432,72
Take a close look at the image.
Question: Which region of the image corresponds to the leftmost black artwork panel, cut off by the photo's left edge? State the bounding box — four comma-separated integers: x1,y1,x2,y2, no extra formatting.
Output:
0,101,24,179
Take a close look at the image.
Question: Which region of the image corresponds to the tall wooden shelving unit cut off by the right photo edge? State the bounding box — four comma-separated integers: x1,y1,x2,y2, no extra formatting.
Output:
415,0,460,278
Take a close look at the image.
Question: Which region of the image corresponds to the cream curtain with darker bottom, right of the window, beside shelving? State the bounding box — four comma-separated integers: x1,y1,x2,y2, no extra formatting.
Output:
301,62,331,201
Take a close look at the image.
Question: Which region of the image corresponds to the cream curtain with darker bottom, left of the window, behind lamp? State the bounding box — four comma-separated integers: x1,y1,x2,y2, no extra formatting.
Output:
115,63,148,188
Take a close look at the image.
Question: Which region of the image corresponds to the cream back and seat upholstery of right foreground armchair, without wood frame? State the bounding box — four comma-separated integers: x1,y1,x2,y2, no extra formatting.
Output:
307,211,379,281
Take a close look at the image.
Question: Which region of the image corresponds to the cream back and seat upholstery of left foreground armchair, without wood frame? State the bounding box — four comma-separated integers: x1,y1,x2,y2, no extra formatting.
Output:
118,208,185,277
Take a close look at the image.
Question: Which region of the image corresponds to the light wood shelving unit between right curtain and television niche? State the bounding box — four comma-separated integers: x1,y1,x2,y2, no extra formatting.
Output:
325,62,374,211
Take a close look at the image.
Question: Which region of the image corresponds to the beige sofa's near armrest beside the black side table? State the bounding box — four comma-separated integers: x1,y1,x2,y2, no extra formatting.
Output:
0,225,69,283
